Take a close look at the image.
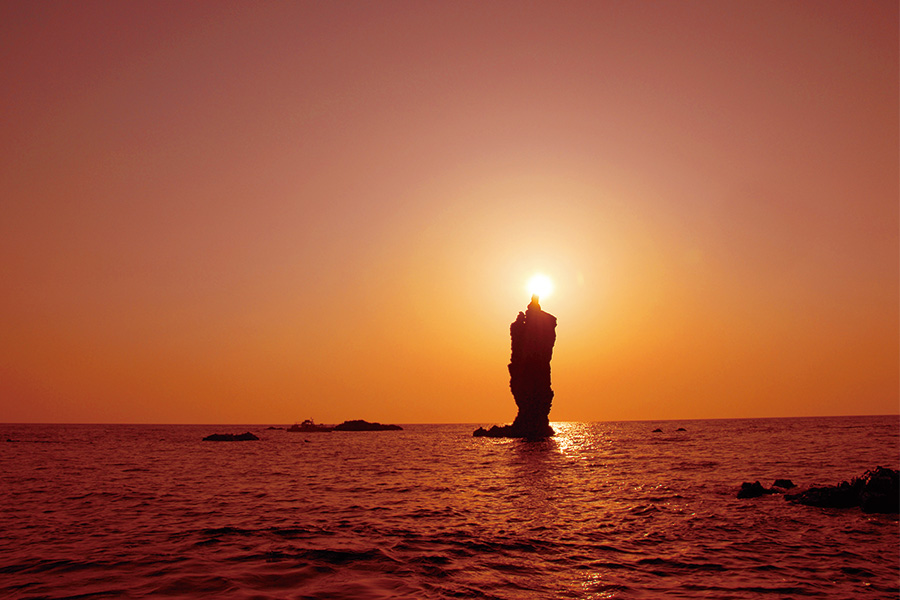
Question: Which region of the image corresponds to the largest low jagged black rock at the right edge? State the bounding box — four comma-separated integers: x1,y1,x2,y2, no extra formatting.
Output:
785,467,900,513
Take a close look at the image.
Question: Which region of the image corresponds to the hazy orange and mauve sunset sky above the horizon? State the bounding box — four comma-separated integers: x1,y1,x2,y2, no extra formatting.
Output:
0,0,900,424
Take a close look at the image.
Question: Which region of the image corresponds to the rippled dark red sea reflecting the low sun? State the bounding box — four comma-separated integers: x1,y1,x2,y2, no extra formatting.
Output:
0,416,900,600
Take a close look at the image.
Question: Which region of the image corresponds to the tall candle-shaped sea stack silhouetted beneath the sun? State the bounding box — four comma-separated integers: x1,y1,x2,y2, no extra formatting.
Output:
473,295,556,439
